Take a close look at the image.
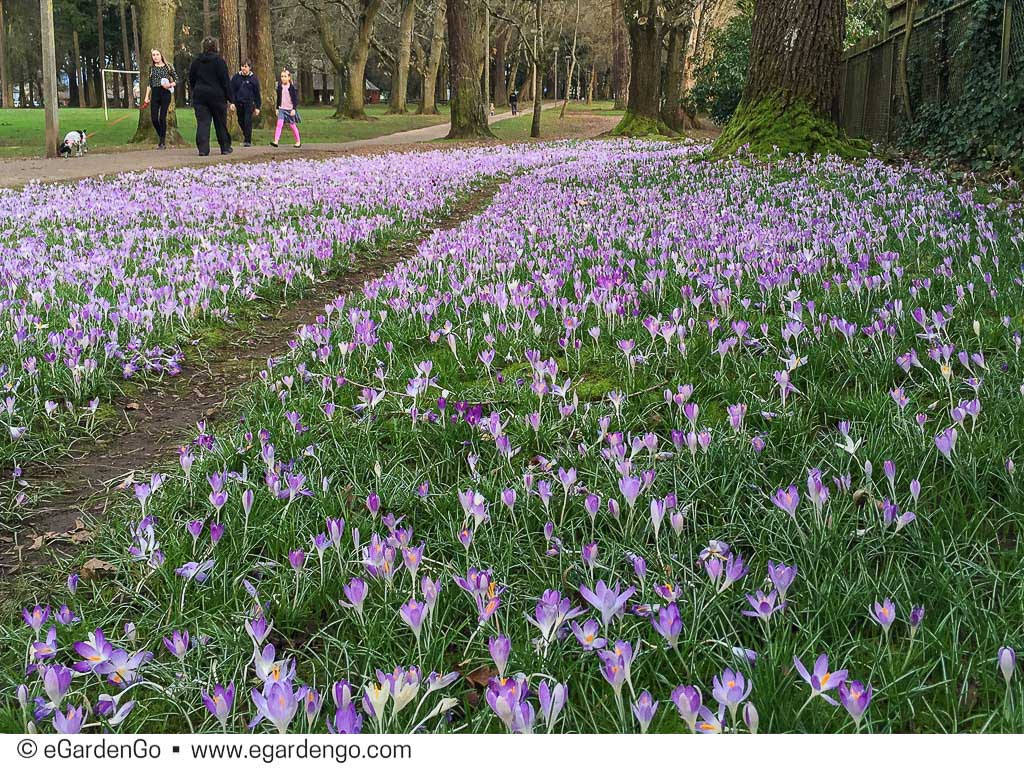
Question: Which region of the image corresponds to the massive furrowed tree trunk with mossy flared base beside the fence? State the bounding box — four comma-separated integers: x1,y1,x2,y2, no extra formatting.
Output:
715,0,865,156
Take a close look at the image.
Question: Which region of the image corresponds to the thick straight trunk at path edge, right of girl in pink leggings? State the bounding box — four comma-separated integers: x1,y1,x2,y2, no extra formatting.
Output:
447,0,495,138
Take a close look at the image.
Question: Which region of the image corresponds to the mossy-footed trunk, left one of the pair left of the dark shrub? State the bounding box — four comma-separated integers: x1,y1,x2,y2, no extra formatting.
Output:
614,0,672,136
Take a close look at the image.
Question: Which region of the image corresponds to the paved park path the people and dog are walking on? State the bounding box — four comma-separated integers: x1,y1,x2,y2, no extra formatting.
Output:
0,103,557,187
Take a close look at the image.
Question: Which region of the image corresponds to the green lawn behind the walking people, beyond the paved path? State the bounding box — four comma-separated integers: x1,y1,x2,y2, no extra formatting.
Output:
0,104,447,158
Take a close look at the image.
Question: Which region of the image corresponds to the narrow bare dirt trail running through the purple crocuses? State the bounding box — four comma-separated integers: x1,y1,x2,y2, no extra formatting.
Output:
0,179,501,577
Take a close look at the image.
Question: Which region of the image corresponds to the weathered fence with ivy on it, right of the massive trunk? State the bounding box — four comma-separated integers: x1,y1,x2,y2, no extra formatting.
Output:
839,0,1024,143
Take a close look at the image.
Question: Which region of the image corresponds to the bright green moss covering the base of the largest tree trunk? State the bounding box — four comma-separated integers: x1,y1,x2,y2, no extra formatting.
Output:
712,96,870,158
